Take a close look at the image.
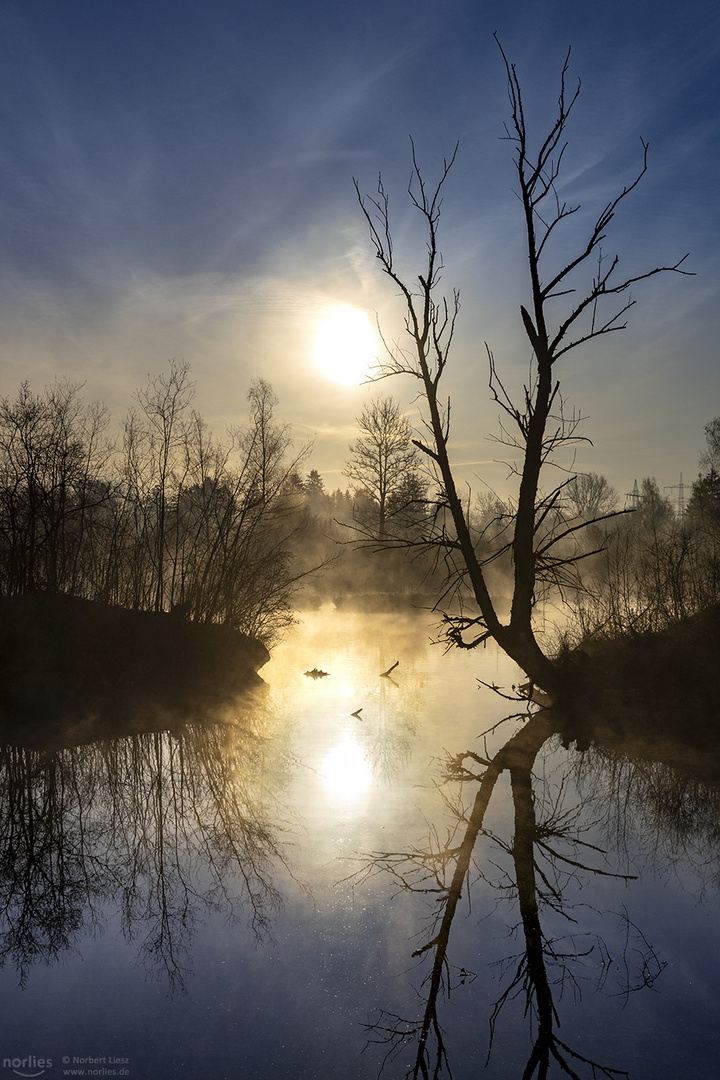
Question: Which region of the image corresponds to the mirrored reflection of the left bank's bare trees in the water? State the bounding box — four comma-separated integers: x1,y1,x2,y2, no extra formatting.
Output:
0,706,293,990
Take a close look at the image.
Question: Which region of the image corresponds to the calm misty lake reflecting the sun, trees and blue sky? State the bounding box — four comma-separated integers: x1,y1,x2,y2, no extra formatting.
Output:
0,608,720,1080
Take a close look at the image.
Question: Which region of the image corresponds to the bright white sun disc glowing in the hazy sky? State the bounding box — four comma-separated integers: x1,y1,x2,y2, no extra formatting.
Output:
314,307,378,387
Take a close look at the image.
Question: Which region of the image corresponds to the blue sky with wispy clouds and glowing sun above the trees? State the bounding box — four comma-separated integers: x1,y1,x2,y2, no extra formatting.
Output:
0,0,720,505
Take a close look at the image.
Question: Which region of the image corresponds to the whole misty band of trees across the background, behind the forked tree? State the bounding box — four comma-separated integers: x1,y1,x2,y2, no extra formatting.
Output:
0,361,720,651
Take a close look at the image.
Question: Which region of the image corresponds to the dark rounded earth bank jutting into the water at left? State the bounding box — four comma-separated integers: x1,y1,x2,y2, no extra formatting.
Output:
0,593,270,745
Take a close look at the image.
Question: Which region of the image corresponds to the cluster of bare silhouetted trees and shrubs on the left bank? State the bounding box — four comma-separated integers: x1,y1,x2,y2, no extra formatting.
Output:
0,361,313,640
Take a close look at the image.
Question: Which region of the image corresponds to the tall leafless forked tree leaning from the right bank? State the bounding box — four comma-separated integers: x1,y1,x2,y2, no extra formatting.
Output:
355,48,687,691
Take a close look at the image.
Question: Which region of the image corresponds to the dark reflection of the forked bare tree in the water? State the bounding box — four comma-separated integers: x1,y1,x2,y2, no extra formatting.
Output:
353,710,664,1080
